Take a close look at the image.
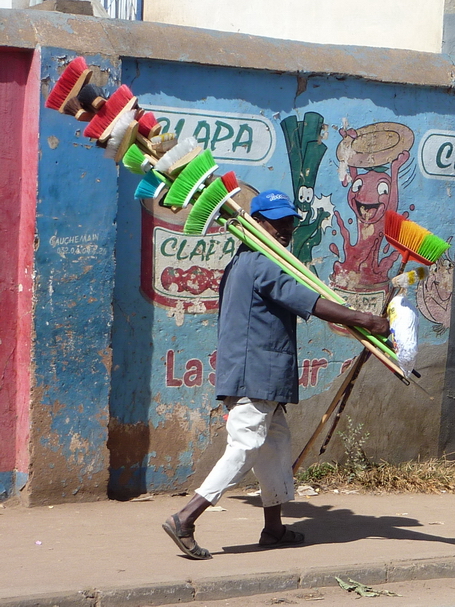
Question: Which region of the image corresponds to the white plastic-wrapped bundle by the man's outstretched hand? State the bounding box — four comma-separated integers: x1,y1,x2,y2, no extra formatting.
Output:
387,295,419,377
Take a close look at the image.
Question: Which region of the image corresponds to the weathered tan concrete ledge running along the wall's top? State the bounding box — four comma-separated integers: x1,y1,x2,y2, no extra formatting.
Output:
0,9,455,89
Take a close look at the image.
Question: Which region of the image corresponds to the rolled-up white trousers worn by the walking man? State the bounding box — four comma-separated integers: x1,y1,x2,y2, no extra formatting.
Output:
196,397,294,508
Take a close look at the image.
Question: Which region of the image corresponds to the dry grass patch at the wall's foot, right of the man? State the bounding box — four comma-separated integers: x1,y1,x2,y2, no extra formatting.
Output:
296,457,455,493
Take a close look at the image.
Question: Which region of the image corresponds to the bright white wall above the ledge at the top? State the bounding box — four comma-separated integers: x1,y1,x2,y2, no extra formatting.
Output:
144,0,444,53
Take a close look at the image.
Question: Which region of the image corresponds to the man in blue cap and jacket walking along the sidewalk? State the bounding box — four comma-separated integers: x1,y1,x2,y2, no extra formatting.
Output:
163,190,389,560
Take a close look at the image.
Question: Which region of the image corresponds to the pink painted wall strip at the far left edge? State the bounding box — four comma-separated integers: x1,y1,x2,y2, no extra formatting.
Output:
0,48,40,484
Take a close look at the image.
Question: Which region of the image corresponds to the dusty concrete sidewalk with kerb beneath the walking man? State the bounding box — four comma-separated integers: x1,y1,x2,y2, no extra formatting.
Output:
0,490,455,607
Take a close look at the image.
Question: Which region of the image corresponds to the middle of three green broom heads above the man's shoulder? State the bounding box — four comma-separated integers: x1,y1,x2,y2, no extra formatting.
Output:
164,150,218,207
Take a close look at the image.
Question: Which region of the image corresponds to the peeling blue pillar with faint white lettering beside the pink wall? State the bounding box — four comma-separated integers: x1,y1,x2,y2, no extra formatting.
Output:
29,49,118,503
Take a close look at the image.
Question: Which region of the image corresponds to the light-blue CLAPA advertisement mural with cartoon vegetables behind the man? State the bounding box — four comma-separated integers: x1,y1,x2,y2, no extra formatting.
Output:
105,60,455,492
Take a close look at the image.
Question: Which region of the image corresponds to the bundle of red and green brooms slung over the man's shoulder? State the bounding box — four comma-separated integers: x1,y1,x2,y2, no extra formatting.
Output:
46,57,449,384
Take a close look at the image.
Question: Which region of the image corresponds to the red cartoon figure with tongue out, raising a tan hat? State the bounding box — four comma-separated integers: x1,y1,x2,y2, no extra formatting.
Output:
330,122,414,314
